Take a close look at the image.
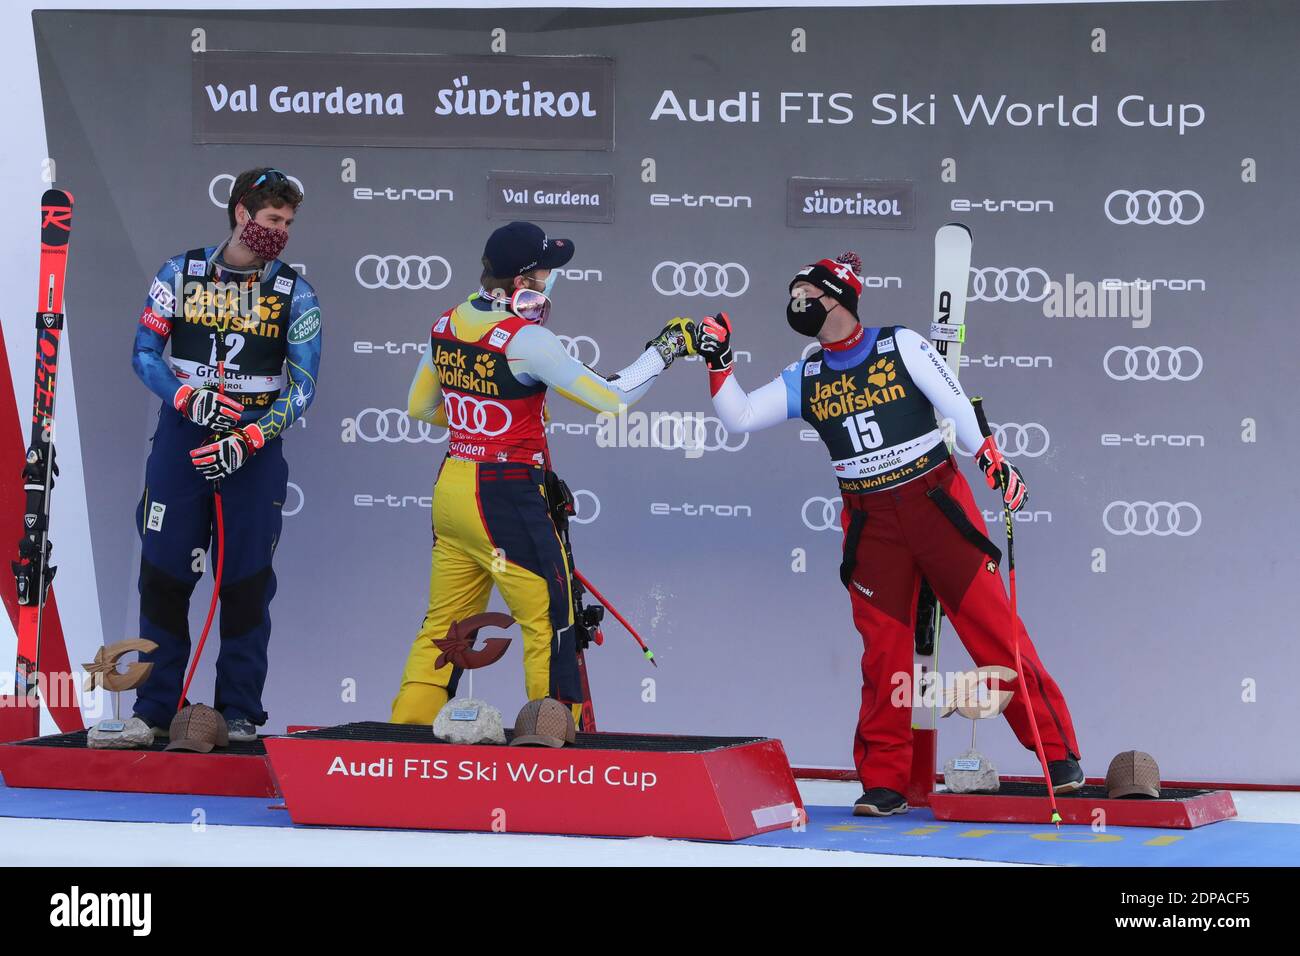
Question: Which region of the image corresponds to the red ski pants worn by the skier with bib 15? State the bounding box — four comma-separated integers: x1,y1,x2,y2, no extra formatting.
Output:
842,460,1079,793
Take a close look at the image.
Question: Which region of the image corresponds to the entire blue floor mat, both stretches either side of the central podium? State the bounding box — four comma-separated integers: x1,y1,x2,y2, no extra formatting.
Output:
0,786,1300,866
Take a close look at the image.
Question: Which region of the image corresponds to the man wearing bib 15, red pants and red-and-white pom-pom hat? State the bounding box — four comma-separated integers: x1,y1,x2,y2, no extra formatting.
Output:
697,252,1084,817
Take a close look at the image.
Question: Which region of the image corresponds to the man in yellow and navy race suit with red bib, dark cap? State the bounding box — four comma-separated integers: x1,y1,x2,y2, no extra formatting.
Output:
393,222,694,724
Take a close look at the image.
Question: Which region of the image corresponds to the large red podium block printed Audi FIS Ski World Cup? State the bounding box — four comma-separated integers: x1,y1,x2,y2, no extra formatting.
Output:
265,722,803,840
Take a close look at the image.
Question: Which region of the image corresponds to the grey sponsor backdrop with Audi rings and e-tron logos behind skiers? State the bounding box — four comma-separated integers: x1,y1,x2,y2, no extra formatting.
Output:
35,3,1300,783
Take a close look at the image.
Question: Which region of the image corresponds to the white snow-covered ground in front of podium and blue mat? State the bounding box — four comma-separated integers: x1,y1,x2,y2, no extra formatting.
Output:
0,780,1300,866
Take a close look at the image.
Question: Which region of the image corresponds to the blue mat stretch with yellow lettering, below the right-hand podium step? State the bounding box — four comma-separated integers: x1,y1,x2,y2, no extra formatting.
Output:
741,806,1300,866
